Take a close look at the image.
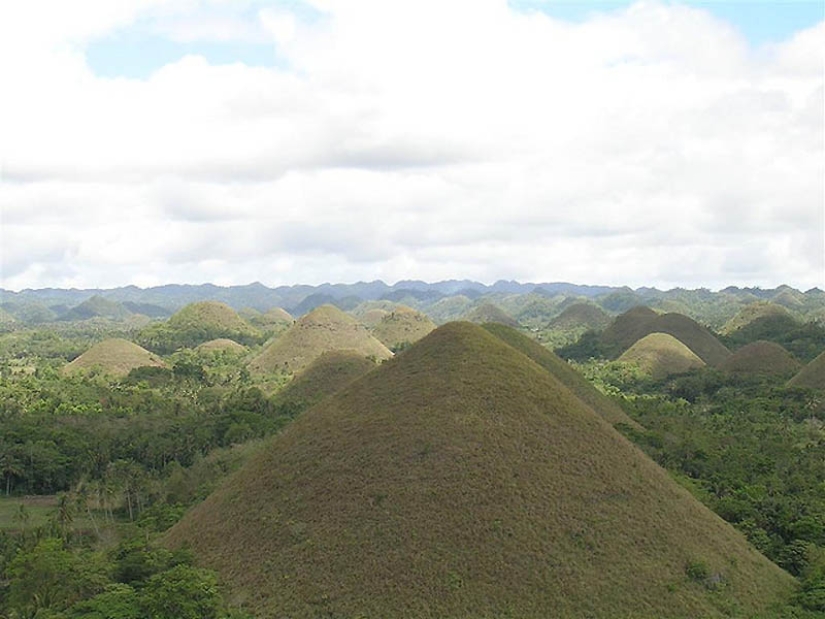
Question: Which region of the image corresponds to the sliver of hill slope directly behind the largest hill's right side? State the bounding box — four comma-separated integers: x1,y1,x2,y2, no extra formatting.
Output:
484,323,641,430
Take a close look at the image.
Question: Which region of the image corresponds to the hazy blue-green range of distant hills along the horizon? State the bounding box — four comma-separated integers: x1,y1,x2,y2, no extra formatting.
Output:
0,280,825,334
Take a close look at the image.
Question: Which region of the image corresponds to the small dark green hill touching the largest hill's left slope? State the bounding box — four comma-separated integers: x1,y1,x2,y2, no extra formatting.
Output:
275,350,377,410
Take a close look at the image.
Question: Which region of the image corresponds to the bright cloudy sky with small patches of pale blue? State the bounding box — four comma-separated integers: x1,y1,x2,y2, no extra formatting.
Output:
0,0,825,290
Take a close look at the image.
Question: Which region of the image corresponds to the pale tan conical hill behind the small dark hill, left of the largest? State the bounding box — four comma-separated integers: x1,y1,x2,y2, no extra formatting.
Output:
249,305,392,374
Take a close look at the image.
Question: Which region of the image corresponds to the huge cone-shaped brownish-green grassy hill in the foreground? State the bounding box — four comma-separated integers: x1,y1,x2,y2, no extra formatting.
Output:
165,323,793,619
